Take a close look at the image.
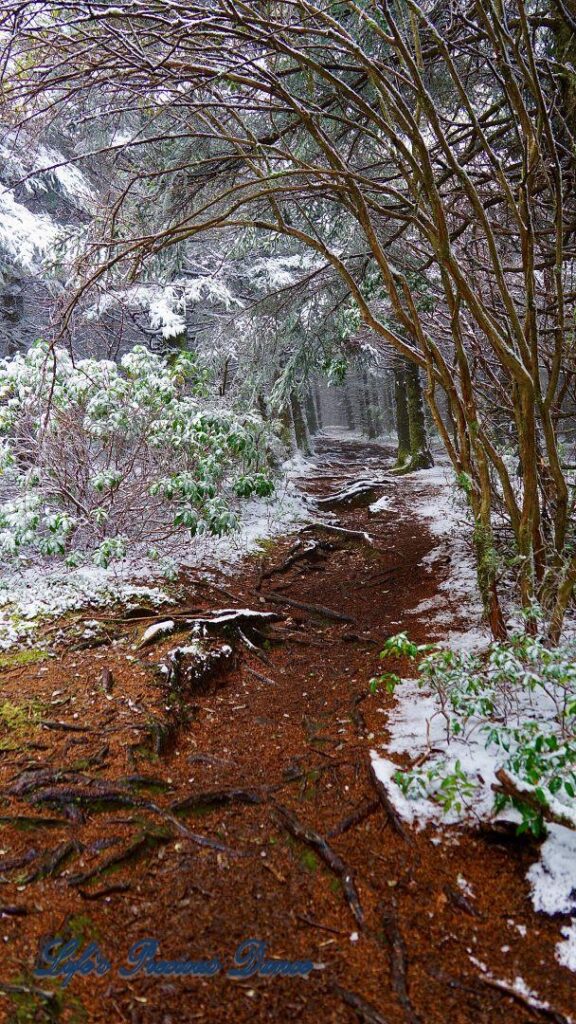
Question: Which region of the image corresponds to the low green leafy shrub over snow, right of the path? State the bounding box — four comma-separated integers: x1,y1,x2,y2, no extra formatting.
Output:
372,631,576,836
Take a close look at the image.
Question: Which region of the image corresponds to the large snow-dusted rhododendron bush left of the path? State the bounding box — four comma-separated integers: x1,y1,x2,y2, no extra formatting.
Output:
0,344,278,566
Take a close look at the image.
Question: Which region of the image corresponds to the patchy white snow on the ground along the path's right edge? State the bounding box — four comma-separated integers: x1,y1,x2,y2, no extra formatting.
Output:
371,466,576,974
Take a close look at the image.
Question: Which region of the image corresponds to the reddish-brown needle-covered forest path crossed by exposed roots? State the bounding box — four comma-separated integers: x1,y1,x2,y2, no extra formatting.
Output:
0,436,576,1024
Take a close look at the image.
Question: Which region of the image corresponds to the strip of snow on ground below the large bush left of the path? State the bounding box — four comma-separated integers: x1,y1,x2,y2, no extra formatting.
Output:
0,456,315,650
